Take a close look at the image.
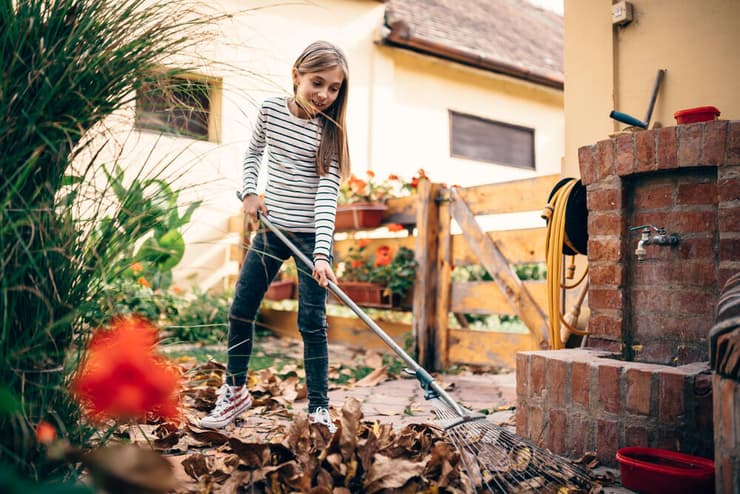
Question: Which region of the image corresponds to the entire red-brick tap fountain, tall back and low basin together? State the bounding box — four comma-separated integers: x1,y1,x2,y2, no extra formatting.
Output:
517,121,740,465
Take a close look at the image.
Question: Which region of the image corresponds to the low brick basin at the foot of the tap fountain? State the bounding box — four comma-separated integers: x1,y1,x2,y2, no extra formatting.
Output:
516,349,714,466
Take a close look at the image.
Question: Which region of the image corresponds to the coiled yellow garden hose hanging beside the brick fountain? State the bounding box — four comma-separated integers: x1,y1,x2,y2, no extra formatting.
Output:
542,179,588,350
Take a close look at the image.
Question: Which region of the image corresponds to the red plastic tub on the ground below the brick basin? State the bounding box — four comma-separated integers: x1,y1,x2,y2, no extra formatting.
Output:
617,446,714,494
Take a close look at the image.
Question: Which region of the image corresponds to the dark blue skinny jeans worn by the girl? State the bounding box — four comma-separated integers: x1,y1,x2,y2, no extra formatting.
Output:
226,229,329,413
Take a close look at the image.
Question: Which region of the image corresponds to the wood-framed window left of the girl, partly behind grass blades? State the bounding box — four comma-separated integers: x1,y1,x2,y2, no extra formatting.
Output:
136,74,222,142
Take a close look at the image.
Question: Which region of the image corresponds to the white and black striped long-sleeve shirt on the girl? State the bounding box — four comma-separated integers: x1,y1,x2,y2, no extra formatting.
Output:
242,97,341,259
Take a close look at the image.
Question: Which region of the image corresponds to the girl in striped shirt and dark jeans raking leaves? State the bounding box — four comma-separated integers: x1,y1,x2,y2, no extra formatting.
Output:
200,41,350,433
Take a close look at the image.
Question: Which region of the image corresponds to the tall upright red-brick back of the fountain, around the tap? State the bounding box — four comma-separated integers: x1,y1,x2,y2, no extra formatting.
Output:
578,120,740,365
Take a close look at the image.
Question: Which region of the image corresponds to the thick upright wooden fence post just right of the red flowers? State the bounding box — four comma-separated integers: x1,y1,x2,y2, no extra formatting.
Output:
413,180,440,367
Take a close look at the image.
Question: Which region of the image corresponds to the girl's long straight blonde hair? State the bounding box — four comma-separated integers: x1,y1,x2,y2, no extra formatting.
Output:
293,41,350,177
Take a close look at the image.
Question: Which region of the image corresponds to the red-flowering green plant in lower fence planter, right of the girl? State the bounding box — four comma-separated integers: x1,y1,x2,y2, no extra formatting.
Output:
336,240,417,297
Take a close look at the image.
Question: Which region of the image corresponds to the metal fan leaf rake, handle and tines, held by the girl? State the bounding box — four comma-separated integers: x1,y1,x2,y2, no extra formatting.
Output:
251,206,601,494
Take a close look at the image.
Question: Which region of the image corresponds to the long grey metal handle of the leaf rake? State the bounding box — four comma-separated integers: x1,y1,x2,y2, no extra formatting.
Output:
249,208,466,417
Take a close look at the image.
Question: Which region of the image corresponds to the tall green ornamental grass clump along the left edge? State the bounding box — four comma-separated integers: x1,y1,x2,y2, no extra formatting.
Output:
0,0,218,478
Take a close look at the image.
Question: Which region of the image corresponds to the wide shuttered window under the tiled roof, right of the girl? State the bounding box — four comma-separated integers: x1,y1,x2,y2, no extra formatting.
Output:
450,111,535,170
